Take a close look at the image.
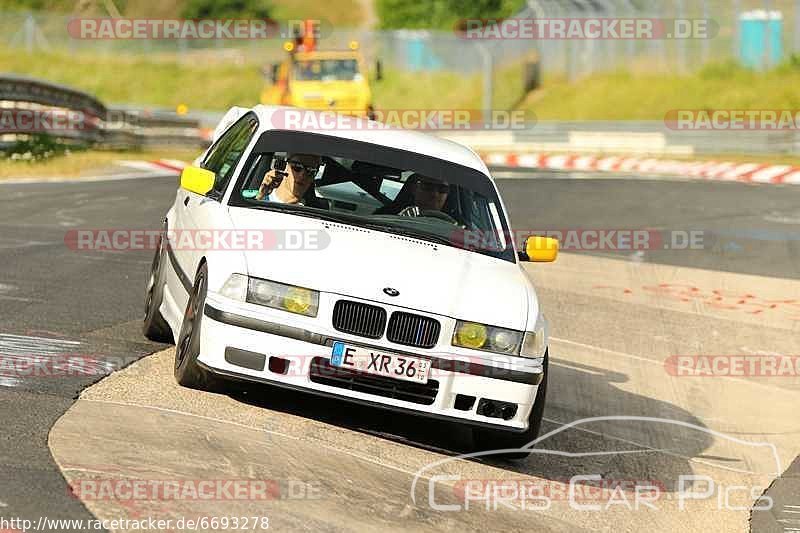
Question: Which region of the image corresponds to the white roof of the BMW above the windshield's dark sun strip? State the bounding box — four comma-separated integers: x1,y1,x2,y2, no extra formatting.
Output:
247,105,491,179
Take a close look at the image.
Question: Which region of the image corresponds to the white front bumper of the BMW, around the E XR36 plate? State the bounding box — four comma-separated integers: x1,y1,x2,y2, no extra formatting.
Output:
198,299,544,432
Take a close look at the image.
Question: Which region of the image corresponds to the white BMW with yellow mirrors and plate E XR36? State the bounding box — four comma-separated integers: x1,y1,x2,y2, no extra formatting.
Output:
144,106,558,450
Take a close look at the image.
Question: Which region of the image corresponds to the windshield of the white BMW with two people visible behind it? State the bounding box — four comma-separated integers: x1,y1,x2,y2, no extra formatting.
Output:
230,132,515,261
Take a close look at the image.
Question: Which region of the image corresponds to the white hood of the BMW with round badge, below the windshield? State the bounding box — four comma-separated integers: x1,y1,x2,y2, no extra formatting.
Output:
231,208,536,330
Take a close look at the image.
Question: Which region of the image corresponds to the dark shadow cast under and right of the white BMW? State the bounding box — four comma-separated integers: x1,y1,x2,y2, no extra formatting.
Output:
231,359,741,491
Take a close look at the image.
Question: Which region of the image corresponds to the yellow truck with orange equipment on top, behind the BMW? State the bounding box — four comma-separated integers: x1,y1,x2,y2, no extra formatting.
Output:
261,41,380,118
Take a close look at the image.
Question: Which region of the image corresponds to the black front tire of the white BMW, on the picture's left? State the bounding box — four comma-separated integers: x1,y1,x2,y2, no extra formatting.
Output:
174,263,215,390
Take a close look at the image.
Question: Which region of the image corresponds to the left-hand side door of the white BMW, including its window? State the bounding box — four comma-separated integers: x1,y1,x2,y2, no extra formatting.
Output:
170,113,258,310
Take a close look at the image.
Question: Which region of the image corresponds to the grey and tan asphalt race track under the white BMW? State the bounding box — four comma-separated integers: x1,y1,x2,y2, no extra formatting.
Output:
0,173,800,531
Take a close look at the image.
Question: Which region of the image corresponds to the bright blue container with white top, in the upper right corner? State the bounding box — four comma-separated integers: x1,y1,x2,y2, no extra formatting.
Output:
739,10,783,70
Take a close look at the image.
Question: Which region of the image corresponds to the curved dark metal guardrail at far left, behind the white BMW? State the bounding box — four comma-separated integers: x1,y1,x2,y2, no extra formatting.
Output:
0,74,205,149
